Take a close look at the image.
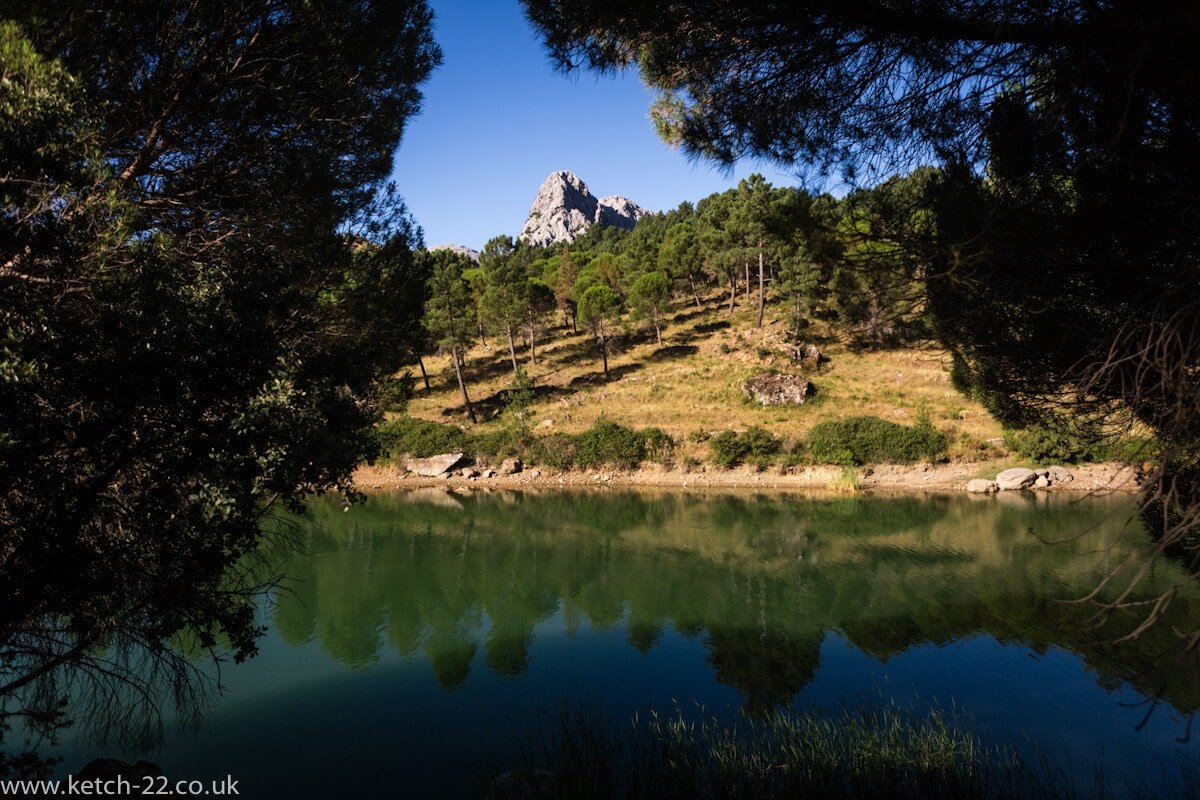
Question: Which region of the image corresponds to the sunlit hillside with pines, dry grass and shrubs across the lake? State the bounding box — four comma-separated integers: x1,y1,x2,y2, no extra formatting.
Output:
380,168,1137,469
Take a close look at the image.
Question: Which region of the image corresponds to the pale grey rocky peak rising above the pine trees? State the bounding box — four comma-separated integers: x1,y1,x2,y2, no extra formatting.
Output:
521,169,649,247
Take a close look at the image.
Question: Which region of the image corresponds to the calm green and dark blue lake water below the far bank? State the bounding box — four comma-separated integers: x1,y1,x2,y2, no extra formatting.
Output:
44,489,1200,798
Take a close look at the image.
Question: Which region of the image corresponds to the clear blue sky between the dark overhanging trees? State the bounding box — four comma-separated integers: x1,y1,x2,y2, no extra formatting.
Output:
394,0,796,249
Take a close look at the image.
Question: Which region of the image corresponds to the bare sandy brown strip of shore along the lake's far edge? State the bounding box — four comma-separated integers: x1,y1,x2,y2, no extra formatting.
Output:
353,462,1139,497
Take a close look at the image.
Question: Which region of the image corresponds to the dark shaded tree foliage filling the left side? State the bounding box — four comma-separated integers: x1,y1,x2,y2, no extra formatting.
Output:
0,0,440,762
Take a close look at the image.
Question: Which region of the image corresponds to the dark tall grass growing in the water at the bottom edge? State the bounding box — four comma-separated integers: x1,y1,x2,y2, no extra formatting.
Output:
486,708,1089,800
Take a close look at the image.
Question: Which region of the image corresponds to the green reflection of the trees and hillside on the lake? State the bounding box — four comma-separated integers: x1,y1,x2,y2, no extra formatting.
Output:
272,492,1200,712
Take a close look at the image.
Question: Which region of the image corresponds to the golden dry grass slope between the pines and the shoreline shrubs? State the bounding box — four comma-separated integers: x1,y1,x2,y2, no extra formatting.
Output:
409,289,1002,461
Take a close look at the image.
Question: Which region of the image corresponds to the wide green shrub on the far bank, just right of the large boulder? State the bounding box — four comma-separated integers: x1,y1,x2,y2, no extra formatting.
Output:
808,416,949,467
